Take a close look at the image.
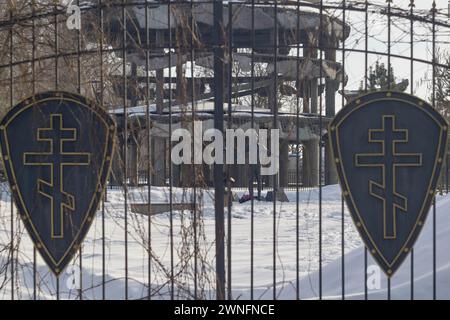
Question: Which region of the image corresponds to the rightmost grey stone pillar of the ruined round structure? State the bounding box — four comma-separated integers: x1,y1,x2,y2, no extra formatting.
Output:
325,39,339,185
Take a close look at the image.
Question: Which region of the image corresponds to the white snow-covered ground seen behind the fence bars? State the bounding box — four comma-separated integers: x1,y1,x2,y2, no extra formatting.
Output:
0,186,450,299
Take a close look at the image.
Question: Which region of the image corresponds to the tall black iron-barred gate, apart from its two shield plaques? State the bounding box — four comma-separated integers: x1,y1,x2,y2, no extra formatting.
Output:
0,0,450,299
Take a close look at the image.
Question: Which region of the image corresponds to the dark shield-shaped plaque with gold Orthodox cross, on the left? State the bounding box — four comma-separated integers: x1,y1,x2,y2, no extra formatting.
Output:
0,92,116,275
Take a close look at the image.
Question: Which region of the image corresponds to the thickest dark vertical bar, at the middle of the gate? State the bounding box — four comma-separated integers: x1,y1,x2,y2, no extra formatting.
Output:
213,0,225,300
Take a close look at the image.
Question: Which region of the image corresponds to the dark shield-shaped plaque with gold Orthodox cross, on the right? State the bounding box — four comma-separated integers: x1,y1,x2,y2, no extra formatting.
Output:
329,91,448,276
